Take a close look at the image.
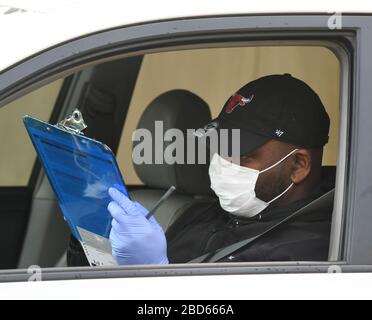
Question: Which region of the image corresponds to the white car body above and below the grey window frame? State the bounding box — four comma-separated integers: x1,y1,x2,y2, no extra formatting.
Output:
0,0,372,299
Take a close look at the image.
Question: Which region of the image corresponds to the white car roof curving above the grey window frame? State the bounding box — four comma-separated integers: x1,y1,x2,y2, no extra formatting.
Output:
0,0,372,71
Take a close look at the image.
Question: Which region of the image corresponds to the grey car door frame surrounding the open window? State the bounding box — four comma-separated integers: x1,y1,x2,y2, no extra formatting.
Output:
0,15,372,279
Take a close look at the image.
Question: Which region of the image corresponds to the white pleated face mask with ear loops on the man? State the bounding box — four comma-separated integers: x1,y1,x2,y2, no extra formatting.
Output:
209,149,298,217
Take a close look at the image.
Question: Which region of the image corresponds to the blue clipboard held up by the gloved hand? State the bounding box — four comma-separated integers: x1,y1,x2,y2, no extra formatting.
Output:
23,116,128,266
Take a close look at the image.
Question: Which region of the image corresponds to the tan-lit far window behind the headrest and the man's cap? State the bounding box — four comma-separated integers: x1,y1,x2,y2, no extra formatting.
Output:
117,46,340,185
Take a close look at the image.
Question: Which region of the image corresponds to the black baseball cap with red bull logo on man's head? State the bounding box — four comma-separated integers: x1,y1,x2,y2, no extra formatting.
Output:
196,73,330,155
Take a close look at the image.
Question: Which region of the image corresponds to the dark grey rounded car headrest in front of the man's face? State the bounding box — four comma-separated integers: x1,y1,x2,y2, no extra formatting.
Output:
133,90,211,195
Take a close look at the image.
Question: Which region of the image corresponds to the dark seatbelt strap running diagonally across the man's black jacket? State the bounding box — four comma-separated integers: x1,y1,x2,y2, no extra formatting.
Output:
188,189,335,263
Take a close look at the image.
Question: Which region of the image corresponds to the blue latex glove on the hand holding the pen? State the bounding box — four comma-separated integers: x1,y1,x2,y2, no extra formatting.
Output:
107,188,168,265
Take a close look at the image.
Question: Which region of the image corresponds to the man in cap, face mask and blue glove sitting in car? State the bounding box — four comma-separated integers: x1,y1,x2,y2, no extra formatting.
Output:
67,74,334,265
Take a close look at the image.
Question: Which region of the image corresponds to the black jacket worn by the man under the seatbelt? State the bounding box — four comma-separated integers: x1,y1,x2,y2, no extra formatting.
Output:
166,169,334,263
